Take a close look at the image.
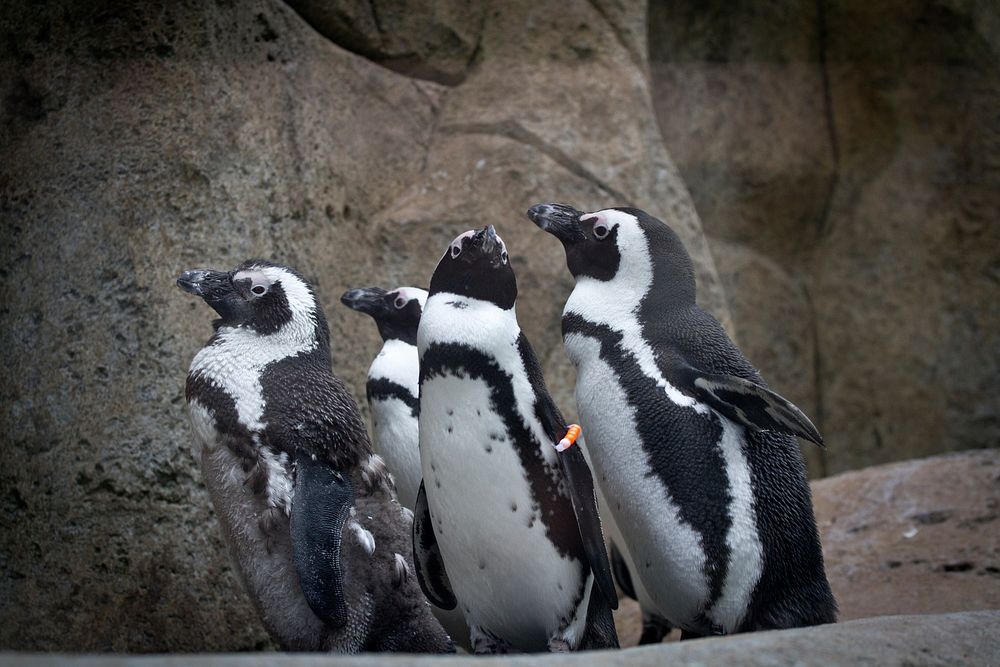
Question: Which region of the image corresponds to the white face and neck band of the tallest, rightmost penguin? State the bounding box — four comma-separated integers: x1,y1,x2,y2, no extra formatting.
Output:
563,209,708,413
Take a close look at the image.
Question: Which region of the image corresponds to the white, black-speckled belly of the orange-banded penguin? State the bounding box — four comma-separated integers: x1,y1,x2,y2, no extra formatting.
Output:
420,375,585,650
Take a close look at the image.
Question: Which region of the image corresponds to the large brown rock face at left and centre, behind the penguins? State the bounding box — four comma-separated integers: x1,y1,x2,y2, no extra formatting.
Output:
0,0,726,651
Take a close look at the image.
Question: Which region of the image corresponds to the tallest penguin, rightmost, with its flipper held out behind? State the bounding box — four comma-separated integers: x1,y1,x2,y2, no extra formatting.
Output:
528,204,837,637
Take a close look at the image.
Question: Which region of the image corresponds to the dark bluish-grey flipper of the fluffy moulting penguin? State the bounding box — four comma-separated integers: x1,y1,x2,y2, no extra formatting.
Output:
289,450,354,628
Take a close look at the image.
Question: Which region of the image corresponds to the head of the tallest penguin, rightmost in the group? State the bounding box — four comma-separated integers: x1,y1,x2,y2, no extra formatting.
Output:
528,204,695,303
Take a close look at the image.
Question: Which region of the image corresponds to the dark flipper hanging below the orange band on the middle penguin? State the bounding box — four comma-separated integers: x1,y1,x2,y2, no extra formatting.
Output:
557,446,618,609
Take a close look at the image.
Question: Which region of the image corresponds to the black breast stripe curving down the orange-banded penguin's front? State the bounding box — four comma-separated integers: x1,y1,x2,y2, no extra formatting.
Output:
420,343,586,567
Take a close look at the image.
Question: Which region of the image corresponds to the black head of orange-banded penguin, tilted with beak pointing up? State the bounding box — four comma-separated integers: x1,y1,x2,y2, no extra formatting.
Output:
430,225,517,310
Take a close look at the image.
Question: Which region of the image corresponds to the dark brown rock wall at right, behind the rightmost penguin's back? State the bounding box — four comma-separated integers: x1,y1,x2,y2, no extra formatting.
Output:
650,0,1000,473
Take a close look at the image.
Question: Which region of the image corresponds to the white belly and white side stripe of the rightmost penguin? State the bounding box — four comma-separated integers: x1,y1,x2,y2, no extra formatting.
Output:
565,333,763,632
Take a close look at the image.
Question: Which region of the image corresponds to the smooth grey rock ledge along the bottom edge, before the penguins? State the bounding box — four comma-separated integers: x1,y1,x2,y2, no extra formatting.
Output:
0,611,1000,667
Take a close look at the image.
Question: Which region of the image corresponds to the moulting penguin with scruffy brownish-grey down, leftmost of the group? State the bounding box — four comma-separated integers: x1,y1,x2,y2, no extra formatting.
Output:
177,260,453,653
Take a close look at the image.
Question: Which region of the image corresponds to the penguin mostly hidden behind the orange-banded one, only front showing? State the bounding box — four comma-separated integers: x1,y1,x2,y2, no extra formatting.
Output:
340,287,427,510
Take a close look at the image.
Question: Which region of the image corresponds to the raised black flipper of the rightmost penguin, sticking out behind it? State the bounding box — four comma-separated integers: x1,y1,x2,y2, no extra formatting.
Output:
676,366,824,447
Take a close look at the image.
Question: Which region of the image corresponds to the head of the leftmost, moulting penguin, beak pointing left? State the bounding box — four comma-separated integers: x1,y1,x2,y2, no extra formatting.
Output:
177,259,329,343
